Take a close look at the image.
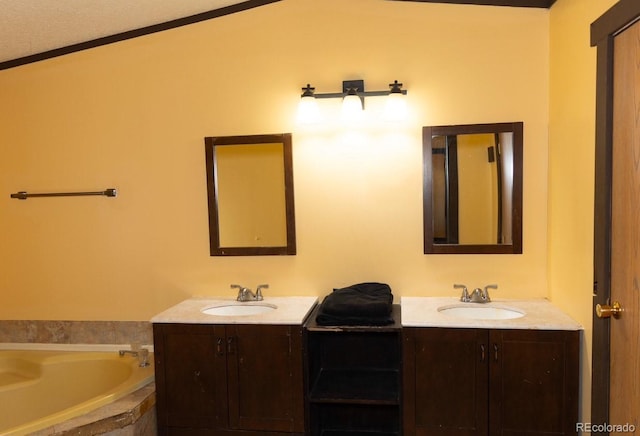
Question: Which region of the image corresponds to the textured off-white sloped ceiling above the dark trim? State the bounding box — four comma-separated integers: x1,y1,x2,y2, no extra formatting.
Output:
0,0,250,62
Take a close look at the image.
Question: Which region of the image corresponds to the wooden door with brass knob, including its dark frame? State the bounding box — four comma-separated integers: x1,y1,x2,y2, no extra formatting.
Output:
591,0,640,431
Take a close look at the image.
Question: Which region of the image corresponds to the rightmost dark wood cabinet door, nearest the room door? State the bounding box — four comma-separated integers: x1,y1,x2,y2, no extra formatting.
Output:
489,330,580,436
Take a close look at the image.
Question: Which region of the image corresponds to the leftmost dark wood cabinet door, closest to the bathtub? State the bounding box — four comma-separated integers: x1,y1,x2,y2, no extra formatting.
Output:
153,324,227,434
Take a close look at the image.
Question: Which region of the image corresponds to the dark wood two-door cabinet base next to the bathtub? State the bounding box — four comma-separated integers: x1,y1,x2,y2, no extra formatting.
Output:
153,324,304,436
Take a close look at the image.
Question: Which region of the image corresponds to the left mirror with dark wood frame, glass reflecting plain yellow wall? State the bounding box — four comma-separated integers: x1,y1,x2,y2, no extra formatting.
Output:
204,133,296,256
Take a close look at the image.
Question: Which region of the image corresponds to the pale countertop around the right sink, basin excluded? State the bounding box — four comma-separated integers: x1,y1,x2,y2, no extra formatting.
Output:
400,297,582,330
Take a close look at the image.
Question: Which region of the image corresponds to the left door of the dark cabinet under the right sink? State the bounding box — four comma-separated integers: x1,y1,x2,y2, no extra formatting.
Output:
403,328,489,436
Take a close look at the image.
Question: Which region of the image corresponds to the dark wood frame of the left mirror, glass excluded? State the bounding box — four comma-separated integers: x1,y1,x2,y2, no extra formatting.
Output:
204,133,296,256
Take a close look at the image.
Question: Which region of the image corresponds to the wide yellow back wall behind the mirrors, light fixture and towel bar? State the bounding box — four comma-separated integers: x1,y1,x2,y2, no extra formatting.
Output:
0,0,549,320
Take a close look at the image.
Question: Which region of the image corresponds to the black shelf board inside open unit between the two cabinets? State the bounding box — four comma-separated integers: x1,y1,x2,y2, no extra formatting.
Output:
309,368,400,405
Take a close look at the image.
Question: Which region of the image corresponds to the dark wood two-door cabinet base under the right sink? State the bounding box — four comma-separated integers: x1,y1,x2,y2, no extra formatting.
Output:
403,327,580,436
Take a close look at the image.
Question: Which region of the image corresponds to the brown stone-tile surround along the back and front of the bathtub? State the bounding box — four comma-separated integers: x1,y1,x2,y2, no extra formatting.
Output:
0,320,157,436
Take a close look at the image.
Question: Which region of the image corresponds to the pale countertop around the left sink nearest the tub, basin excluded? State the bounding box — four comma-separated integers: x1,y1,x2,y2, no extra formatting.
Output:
151,297,318,325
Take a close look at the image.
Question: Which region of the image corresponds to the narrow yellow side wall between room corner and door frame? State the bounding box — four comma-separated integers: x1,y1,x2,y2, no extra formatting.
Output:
548,0,615,422
